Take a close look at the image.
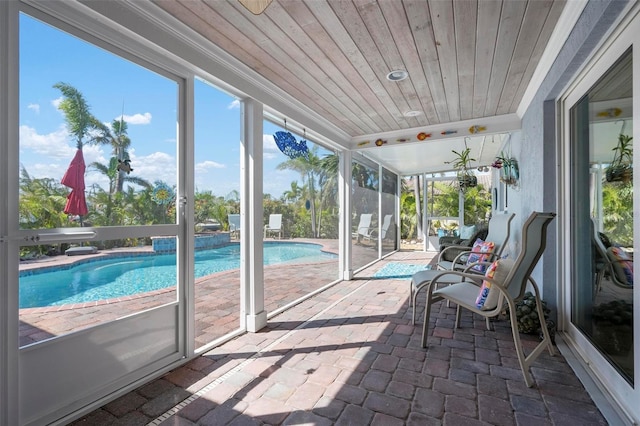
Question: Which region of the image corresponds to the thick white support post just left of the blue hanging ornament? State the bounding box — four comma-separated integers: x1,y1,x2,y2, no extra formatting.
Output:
240,99,267,333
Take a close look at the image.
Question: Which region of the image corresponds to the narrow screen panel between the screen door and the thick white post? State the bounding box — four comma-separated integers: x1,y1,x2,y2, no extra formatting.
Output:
193,79,243,352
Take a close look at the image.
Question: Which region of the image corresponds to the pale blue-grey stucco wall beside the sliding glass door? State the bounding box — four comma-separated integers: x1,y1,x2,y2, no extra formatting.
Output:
509,1,627,315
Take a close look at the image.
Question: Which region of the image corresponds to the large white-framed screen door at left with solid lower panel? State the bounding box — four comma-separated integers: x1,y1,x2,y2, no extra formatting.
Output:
16,8,188,424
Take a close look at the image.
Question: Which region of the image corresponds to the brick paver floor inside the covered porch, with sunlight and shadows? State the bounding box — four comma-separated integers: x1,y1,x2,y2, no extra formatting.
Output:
67,252,607,426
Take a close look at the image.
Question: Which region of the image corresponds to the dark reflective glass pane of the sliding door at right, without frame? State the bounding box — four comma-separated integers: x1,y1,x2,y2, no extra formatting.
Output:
571,50,634,385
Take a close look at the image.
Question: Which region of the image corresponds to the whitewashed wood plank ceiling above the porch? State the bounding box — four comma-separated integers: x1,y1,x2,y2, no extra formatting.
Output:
153,0,565,173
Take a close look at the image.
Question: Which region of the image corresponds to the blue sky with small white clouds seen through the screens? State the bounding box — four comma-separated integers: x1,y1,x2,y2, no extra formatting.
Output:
19,15,328,197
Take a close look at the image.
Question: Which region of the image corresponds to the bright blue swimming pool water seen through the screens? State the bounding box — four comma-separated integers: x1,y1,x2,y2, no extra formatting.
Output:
20,243,337,308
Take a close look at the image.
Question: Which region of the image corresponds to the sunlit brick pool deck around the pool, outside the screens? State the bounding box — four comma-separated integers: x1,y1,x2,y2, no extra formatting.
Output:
19,239,384,348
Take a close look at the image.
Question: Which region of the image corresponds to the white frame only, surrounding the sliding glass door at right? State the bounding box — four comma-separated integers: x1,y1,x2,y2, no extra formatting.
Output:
557,4,640,423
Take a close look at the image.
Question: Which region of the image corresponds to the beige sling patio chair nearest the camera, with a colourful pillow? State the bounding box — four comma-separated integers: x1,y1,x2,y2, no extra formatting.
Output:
422,212,556,387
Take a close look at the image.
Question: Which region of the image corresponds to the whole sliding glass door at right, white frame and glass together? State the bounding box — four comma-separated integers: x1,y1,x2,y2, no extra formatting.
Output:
561,9,640,419
